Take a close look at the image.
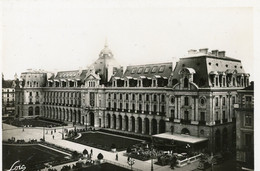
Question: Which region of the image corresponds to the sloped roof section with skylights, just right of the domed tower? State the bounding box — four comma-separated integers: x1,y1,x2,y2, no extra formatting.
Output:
114,62,172,79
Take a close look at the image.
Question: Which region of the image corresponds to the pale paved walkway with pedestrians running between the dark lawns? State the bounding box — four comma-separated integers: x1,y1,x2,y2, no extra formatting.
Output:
2,123,198,171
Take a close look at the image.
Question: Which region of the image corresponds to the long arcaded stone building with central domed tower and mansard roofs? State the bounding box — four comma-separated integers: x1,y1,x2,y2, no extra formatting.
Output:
16,45,249,152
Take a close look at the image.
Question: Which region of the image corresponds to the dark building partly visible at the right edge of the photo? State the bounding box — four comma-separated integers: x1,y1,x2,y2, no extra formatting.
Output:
235,83,254,170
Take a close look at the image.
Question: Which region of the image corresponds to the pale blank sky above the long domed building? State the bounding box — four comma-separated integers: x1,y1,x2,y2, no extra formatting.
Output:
1,0,254,80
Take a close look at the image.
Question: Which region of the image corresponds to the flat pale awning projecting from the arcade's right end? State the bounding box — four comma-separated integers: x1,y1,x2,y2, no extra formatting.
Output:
153,133,208,144
